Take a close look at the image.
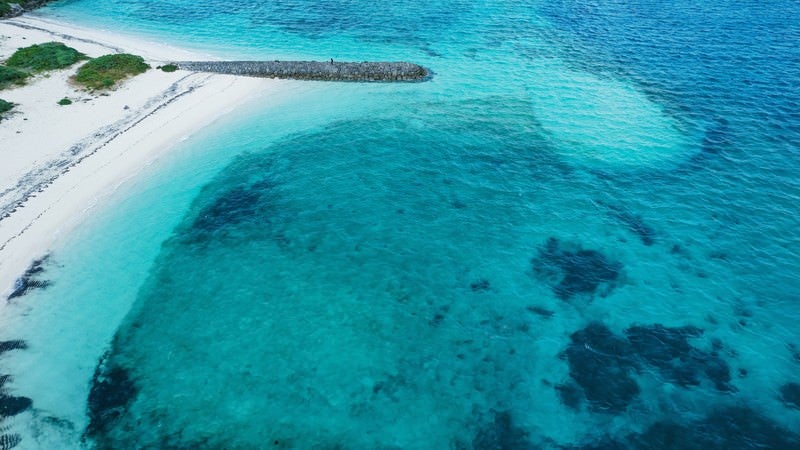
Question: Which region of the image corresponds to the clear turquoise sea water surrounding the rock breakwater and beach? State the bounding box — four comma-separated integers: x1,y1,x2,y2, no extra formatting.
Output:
0,0,800,449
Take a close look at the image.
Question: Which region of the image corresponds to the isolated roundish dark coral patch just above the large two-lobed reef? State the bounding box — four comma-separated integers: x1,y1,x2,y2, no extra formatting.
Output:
531,237,622,300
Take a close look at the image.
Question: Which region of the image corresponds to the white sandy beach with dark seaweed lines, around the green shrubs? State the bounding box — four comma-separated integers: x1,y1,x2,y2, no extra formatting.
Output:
0,16,282,298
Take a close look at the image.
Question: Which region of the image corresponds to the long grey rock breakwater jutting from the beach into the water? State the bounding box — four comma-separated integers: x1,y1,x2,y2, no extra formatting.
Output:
175,61,430,82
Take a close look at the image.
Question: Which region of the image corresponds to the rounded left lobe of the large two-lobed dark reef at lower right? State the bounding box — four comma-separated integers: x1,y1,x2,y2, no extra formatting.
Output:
565,322,639,413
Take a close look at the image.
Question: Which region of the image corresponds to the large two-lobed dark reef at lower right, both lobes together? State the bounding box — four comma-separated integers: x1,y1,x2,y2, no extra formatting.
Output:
556,322,735,414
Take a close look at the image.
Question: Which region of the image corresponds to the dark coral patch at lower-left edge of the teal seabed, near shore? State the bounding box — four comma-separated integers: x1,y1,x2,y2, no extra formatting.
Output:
86,355,137,436
